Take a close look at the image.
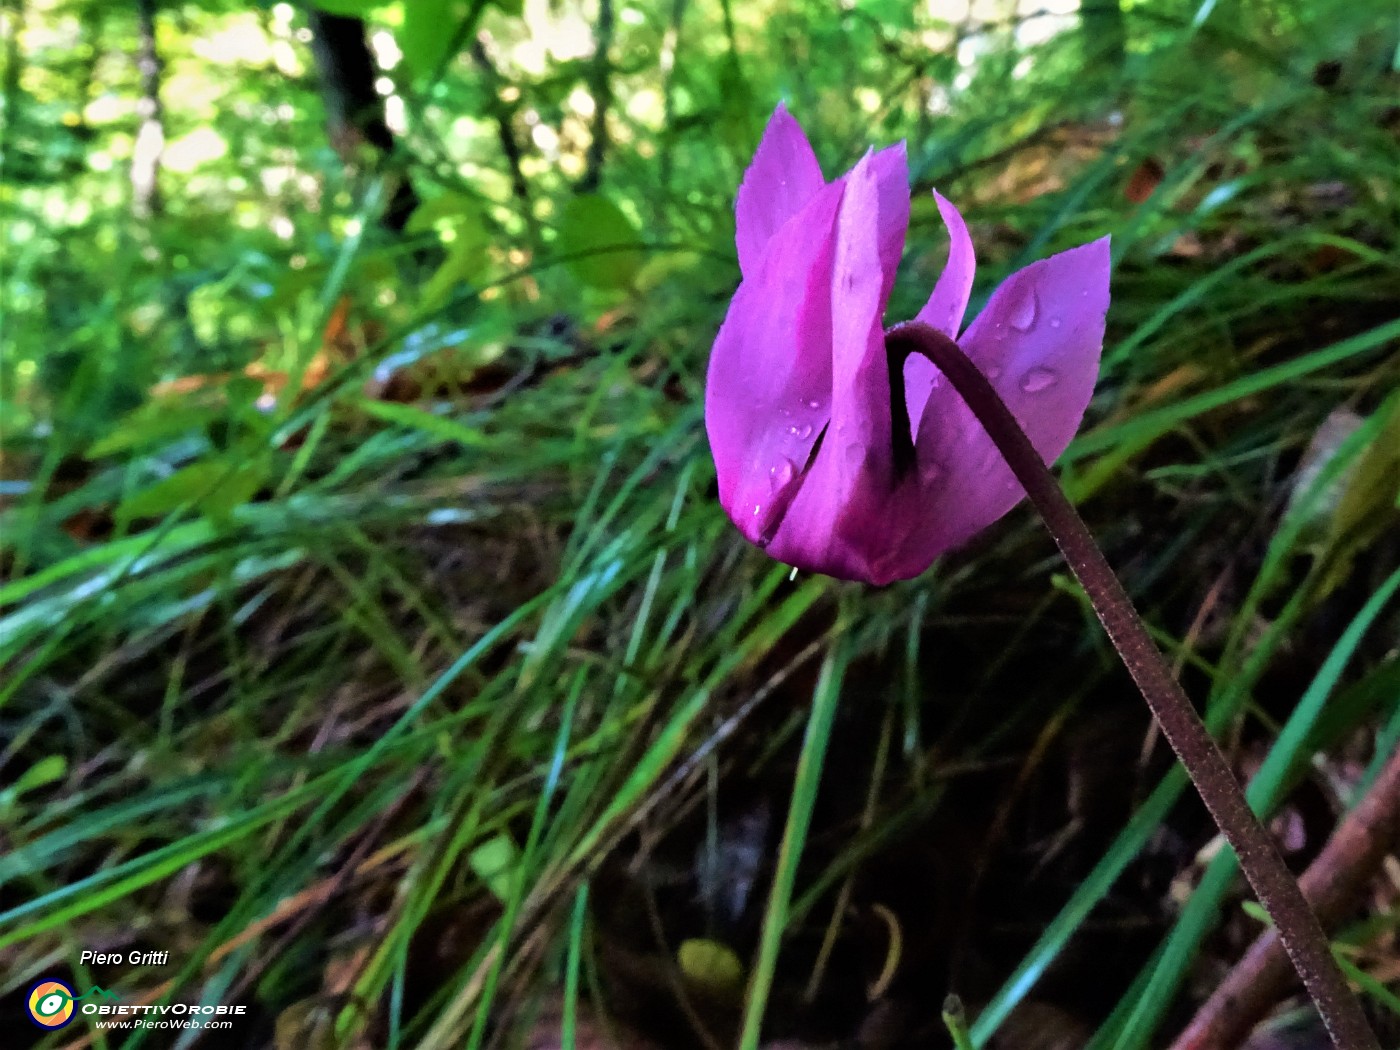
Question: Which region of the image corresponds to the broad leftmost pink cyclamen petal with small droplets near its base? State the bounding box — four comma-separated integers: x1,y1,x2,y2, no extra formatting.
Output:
706,183,846,543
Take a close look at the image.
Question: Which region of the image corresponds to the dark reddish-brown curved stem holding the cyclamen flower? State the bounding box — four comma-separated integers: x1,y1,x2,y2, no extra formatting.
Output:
885,322,1379,1050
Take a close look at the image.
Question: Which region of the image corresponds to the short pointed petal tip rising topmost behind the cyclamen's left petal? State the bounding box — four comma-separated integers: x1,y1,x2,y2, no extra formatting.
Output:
734,104,826,277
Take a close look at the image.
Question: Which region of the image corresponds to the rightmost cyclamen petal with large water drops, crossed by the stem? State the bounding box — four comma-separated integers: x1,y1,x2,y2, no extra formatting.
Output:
916,237,1109,556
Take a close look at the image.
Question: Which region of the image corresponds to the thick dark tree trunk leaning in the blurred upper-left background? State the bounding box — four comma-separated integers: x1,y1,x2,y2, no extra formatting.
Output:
308,8,419,232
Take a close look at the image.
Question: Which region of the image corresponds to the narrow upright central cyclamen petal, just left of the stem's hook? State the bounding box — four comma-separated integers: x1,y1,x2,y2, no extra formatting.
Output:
769,157,916,582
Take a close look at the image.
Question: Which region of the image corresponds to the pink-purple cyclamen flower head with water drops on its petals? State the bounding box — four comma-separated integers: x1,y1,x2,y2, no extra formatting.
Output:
706,105,1109,584
